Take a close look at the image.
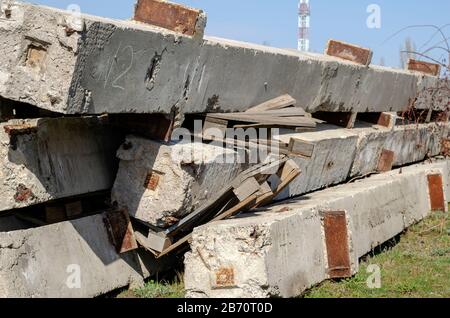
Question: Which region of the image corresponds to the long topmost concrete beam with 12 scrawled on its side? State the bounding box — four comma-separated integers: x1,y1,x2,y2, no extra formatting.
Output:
0,0,442,114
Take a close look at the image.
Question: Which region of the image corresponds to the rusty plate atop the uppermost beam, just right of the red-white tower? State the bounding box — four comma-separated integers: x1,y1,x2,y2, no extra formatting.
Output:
325,40,373,66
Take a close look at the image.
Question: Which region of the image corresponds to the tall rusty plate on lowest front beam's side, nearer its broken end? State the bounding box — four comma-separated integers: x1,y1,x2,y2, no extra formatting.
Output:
322,211,351,278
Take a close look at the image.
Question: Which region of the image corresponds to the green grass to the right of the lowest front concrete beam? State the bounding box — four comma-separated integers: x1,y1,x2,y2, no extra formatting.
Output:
305,212,450,298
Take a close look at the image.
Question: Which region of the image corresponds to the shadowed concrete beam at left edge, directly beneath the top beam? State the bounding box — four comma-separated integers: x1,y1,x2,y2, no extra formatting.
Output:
0,117,123,211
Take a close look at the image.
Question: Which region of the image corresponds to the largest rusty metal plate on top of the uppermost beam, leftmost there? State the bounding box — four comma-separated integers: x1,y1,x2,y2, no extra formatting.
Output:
134,0,201,36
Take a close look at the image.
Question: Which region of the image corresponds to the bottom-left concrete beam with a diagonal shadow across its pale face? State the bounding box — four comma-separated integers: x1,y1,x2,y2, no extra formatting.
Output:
0,215,171,298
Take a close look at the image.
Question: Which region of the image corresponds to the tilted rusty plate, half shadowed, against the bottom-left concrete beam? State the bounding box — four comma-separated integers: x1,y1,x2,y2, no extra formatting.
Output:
103,210,138,254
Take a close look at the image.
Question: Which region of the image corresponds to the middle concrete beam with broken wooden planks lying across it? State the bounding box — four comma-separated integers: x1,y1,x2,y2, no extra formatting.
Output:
112,123,450,227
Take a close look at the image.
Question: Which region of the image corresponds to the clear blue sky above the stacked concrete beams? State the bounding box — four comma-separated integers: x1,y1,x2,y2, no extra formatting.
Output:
29,0,450,67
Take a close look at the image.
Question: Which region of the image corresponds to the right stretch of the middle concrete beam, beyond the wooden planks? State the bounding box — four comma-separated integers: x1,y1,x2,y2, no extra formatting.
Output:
275,123,449,200
